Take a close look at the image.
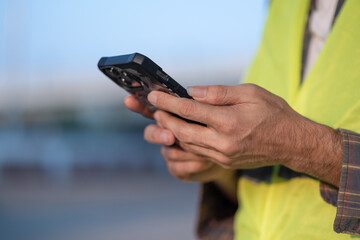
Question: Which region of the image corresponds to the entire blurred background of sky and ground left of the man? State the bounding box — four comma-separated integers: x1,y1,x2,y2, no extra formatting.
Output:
0,0,268,240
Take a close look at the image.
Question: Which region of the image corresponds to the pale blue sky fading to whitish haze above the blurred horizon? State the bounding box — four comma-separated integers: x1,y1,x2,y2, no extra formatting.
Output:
0,0,267,108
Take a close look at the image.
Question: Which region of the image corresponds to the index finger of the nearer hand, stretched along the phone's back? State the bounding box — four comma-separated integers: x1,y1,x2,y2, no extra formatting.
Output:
148,91,219,126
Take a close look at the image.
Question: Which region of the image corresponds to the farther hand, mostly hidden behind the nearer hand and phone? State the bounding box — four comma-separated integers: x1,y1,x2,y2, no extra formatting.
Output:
124,96,237,201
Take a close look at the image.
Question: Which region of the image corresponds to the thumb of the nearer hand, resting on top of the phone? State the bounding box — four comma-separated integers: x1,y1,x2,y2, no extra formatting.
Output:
187,85,244,106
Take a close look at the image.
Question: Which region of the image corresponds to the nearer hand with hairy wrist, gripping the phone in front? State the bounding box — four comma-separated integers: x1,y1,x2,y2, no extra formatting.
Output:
148,84,342,186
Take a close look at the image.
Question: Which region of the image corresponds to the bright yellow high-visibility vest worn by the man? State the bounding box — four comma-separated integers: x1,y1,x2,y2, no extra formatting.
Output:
235,0,360,240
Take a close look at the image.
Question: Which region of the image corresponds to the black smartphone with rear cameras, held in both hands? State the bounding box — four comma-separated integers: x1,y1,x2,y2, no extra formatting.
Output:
98,53,204,125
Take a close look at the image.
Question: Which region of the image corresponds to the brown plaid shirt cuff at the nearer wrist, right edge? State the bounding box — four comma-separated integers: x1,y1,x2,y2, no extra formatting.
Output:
320,129,360,235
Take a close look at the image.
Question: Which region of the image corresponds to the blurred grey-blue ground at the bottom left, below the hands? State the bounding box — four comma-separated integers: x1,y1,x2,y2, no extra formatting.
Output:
0,171,198,240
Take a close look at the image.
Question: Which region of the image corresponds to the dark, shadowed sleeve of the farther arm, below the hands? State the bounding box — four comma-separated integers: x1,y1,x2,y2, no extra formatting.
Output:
197,183,238,240
